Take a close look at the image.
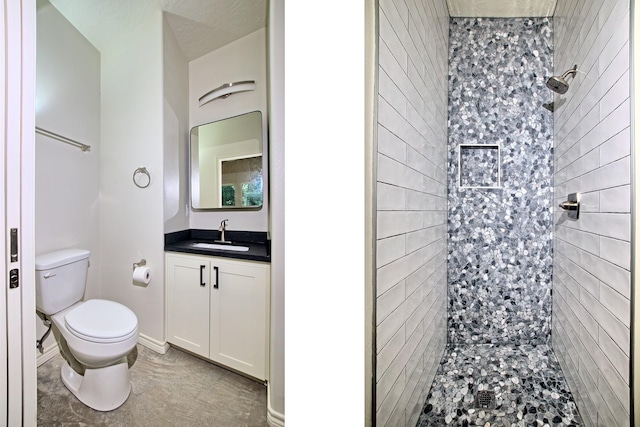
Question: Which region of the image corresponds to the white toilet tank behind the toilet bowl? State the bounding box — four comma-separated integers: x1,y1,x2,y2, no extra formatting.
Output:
35,249,90,315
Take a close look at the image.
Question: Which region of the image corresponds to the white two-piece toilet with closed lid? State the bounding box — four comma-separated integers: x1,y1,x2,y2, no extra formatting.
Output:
35,249,138,411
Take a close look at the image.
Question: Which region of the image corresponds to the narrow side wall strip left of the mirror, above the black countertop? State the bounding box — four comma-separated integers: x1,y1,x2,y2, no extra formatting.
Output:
162,15,189,233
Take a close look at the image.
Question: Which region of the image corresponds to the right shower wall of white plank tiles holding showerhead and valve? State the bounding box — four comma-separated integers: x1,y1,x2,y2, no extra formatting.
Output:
552,0,631,426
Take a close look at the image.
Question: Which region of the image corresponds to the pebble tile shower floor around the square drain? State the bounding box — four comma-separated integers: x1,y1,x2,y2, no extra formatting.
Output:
417,344,583,427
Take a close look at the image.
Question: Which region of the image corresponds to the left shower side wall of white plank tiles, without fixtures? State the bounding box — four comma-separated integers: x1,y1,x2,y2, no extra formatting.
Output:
375,0,449,427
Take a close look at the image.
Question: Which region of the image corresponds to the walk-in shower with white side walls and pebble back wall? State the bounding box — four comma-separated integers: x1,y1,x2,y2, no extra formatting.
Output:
370,0,635,427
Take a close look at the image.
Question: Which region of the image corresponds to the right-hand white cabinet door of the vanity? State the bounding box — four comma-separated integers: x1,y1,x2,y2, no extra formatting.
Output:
209,258,270,380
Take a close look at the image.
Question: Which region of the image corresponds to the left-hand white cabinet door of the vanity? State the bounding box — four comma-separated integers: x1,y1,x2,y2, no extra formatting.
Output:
166,254,211,358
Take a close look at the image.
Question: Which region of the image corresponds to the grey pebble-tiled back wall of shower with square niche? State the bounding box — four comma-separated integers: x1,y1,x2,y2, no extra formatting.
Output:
448,18,553,344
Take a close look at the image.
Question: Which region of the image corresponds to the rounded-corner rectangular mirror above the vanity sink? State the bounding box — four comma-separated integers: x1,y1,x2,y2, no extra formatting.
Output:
190,111,266,209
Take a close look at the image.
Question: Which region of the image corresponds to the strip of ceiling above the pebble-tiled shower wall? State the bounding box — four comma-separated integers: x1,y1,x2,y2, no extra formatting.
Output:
447,0,556,18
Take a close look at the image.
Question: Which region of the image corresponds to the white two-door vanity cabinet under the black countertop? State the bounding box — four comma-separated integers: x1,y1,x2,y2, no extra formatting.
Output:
165,253,270,380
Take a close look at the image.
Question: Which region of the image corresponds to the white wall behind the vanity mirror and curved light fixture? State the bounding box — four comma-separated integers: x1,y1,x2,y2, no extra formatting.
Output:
189,28,269,231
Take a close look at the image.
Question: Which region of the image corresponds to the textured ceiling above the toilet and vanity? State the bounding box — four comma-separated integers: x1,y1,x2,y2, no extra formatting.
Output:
50,0,267,61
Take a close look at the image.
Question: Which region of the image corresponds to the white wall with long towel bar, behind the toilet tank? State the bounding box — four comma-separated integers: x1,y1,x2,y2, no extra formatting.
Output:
35,1,100,354
